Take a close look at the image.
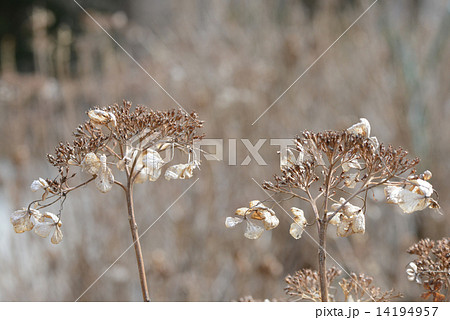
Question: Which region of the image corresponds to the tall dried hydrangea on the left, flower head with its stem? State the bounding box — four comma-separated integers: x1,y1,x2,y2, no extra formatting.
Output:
11,101,203,301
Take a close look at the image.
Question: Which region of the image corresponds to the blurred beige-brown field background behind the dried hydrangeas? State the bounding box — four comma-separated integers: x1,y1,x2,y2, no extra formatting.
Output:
0,0,450,301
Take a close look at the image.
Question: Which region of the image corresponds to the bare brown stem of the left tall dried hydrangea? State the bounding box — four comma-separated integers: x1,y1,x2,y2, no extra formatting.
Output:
125,179,150,302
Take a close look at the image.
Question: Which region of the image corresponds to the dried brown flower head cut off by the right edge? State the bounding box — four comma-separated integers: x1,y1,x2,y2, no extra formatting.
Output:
406,238,450,302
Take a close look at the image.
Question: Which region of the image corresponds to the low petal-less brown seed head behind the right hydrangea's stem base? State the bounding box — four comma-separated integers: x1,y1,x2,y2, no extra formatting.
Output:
284,267,402,302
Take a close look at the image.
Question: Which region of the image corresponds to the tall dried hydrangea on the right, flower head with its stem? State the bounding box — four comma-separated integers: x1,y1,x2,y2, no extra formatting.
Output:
225,118,439,301
